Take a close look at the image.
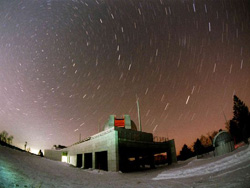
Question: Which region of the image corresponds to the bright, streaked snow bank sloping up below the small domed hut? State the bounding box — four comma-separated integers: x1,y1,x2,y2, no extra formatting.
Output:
153,147,250,180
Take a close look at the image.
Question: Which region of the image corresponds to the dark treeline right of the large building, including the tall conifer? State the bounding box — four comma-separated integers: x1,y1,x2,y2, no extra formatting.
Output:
178,95,250,160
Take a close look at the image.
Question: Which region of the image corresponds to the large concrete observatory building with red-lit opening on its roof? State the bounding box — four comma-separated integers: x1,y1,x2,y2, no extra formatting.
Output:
45,115,177,171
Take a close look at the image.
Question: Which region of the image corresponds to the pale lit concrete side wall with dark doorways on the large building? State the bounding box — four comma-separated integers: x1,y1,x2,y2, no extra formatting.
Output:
67,128,119,171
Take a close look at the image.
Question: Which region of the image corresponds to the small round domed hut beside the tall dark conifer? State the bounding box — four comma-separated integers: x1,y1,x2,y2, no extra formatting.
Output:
213,131,234,156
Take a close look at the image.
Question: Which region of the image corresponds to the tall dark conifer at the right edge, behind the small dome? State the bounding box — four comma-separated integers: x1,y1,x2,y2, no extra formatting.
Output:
229,95,250,143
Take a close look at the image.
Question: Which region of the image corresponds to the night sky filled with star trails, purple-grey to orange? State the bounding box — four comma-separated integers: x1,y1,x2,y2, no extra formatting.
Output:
0,0,250,151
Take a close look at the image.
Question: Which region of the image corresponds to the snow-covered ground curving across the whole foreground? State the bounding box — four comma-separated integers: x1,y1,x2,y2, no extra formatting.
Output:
0,146,250,188
